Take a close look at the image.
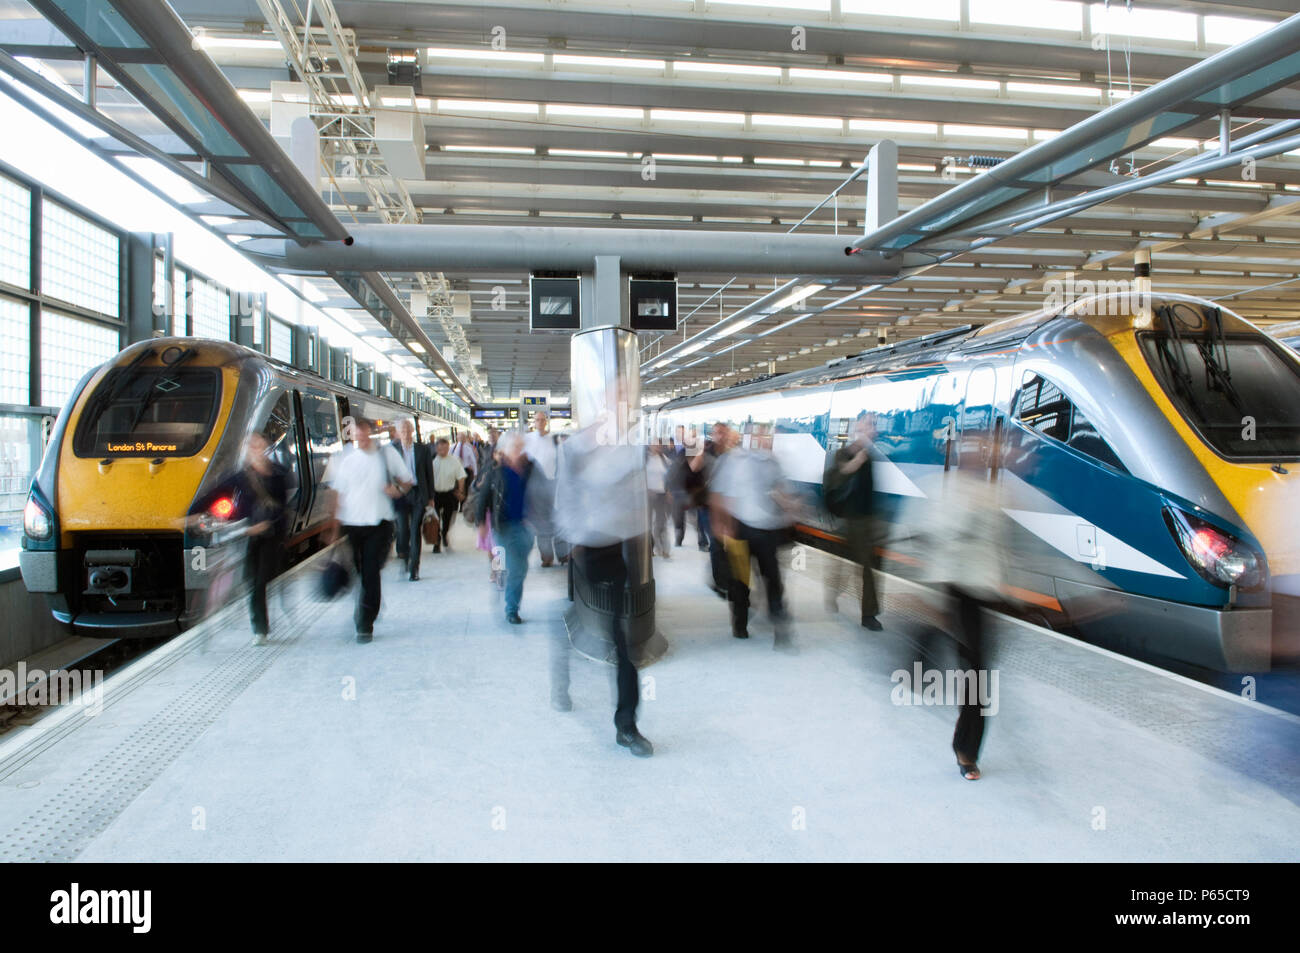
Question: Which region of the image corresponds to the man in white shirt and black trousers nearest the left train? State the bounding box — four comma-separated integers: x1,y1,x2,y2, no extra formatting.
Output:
325,417,415,642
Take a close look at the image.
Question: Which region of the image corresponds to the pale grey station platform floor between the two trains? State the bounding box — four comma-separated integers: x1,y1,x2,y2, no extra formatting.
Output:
0,524,1300,862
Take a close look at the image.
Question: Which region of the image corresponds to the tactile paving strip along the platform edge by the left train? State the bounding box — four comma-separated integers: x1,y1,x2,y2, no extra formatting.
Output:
0,561,329,863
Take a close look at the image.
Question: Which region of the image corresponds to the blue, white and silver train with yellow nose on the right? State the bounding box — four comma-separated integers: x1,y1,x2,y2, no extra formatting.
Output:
649,294,1300,671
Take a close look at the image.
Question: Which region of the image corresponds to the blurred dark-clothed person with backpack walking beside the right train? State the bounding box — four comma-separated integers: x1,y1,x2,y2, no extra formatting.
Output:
822,411,883,632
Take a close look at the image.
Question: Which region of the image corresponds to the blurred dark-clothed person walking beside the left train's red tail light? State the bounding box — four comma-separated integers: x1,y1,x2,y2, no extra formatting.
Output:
191,432,290,645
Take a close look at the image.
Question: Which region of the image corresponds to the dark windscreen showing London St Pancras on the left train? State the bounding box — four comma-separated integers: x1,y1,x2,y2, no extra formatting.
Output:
73,367,221,458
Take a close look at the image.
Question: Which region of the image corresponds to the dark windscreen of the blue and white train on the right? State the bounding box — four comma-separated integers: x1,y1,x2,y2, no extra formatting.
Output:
1139,330,1300,460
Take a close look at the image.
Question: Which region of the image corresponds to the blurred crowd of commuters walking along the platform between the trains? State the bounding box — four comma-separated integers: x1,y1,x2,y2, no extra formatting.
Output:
215,411,998,780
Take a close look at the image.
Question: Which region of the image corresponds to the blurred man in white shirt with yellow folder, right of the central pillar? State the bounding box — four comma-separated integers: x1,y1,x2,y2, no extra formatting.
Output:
710,424,794,651
